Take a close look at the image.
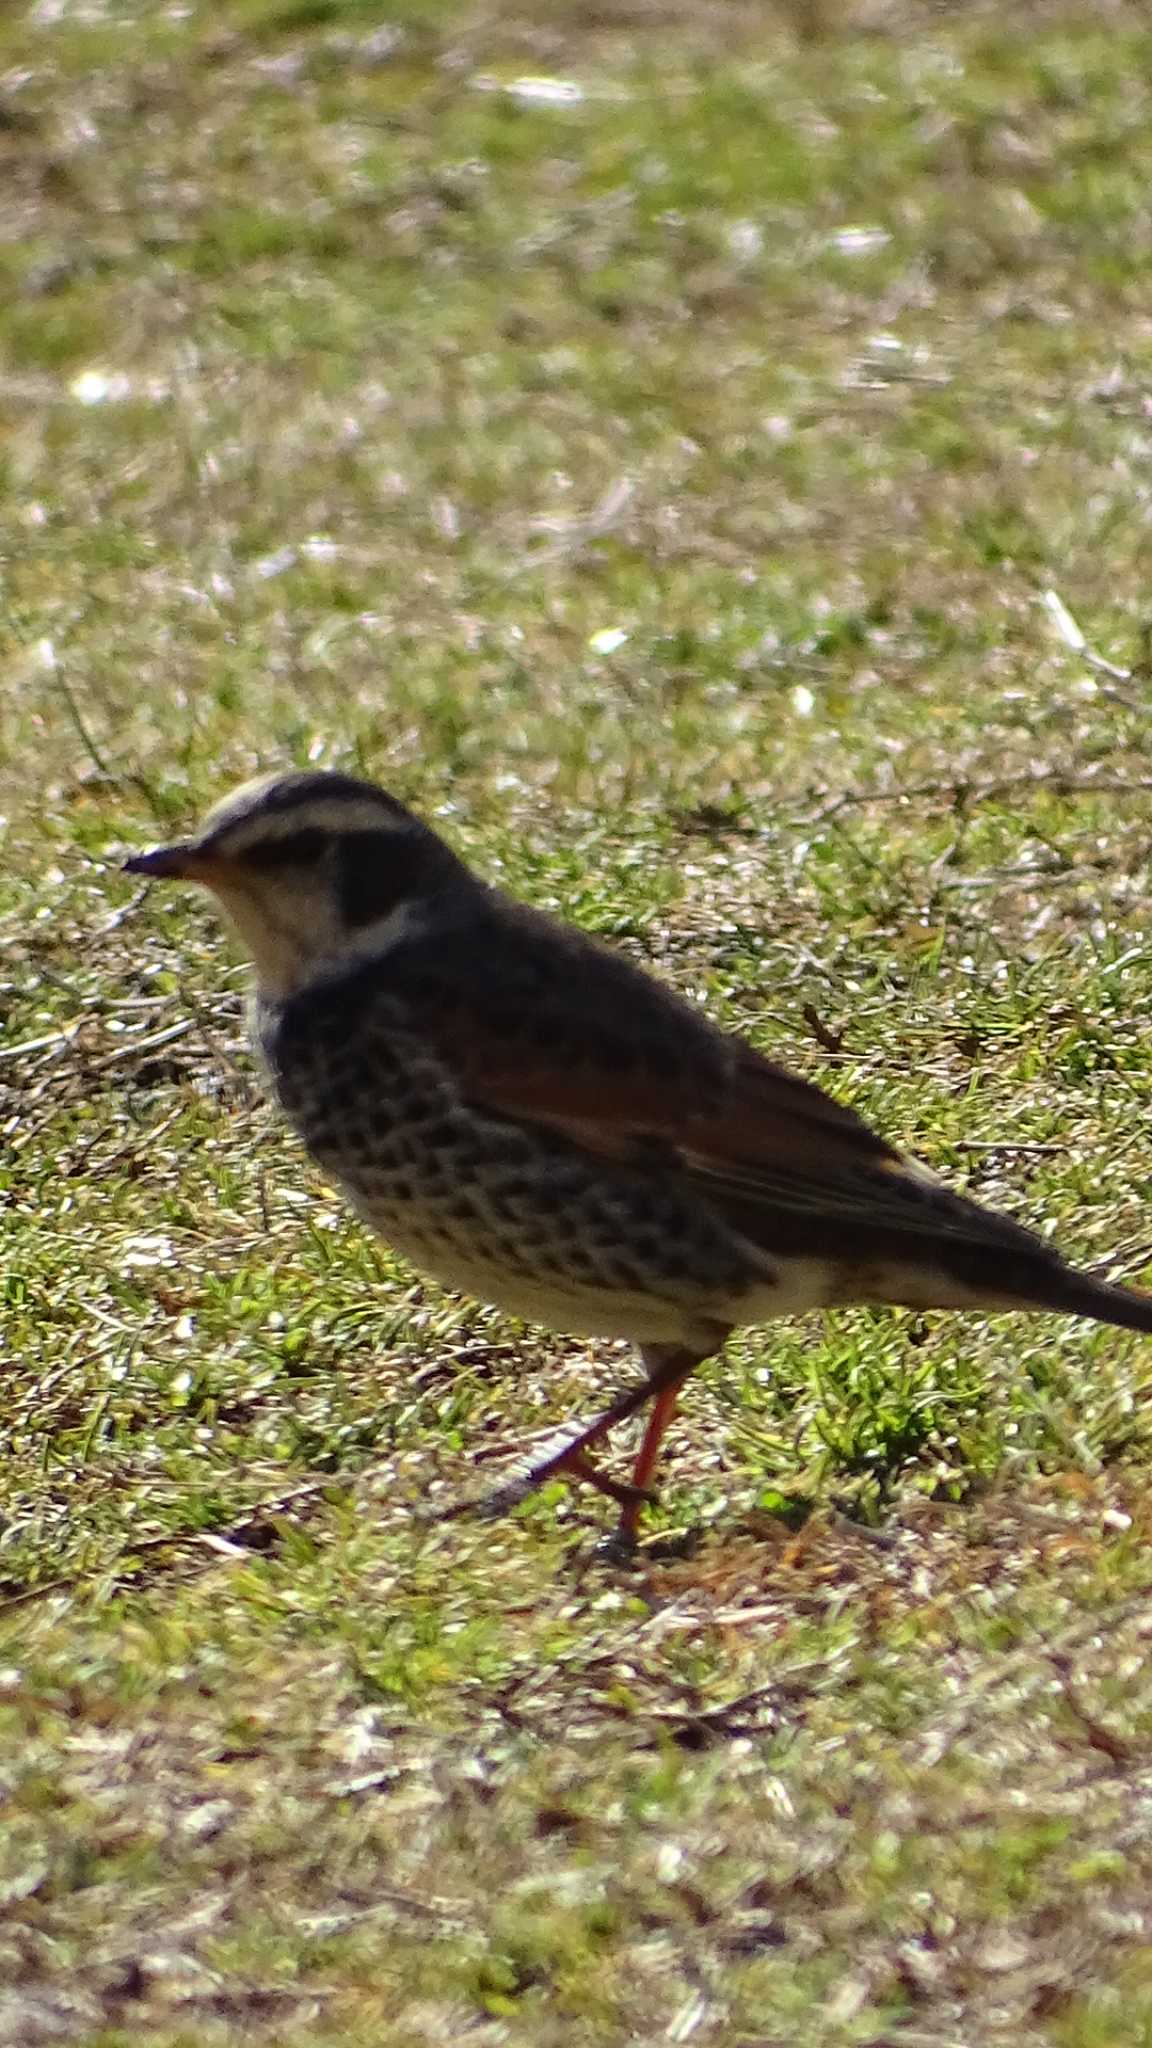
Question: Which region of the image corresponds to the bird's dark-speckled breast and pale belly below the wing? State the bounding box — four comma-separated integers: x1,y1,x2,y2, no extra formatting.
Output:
256,989,763,1341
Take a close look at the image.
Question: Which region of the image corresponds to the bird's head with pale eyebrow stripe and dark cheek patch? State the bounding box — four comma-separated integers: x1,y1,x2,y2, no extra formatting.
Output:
125,770,469,997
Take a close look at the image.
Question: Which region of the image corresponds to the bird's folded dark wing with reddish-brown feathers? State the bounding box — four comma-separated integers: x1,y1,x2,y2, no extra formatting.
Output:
383,905,1052,1266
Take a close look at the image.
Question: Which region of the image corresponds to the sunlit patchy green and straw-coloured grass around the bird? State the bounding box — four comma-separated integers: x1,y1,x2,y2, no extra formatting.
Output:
0,0,1152,2048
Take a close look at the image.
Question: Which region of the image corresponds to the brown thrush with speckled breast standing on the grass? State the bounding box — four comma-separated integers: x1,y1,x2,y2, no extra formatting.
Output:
125,770,1152,1552
